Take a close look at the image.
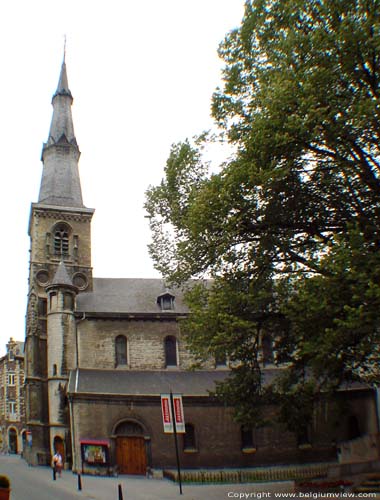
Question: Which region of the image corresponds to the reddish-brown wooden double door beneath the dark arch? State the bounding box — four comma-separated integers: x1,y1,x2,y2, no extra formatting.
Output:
116,436,146,475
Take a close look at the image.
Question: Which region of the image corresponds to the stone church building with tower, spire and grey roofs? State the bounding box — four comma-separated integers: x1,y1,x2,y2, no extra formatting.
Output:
24,58,377,474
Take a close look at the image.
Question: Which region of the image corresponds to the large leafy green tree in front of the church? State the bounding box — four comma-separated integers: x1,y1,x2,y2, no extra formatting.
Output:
146,0,380,428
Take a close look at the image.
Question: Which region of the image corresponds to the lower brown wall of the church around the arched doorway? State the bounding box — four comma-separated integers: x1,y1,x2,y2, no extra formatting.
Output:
73,397,335,468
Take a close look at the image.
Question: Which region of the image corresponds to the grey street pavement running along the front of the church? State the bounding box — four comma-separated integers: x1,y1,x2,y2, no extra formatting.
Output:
0,455,293,500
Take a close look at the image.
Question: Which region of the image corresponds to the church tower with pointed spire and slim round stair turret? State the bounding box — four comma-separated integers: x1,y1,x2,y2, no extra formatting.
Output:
25,60,94,464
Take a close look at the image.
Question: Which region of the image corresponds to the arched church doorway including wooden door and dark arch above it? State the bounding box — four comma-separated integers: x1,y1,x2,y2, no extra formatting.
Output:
114,420,147,475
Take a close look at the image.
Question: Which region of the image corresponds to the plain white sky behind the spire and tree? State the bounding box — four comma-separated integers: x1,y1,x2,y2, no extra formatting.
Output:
0,0,243,354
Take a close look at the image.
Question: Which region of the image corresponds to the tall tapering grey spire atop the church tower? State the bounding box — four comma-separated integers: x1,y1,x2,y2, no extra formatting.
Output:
38,57,83,207
